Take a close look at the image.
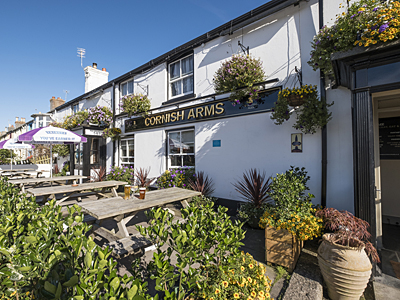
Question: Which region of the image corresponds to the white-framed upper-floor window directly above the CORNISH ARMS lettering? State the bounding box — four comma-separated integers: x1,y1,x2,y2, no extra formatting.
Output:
169,55,194,98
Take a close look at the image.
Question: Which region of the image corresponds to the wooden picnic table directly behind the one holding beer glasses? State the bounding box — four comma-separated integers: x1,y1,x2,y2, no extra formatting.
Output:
26,180,128,204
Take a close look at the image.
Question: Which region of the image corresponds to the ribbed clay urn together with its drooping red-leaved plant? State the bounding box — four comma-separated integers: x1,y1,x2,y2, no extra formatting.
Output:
317,208,379,300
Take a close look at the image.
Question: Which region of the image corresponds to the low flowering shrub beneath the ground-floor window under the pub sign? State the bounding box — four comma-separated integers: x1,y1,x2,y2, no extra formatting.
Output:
157,167,196,189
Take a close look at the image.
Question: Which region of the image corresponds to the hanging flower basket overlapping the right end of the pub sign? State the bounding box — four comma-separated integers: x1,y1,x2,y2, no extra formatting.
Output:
271,85,333,134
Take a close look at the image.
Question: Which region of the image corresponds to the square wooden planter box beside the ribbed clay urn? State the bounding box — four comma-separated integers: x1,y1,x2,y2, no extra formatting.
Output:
265,226,303,272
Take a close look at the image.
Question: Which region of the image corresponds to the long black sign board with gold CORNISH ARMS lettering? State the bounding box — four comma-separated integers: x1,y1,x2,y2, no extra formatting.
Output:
125,88,280,132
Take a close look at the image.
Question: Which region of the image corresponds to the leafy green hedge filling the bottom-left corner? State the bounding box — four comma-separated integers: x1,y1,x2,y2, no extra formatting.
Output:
0,178,147,300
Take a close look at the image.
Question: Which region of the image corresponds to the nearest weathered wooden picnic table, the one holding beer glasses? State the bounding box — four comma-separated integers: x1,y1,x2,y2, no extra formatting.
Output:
79,187,201,257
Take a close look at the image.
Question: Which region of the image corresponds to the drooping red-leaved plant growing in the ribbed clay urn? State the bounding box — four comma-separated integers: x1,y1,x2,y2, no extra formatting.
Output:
316,208,380,262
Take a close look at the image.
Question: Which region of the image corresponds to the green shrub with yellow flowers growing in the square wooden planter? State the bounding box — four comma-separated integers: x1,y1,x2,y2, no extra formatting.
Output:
260,166,323,240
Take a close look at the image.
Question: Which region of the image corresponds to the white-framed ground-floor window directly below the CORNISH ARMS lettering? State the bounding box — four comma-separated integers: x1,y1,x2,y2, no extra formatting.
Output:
168,129,194,168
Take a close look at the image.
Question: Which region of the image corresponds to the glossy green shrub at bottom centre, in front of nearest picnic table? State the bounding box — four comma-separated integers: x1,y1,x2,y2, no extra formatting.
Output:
133,204,244,300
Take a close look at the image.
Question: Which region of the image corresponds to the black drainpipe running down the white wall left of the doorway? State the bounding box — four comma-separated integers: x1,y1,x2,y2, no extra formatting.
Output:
318,0,328,207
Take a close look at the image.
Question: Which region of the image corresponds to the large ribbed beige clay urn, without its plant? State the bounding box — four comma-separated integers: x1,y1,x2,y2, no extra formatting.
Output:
318,233,372,300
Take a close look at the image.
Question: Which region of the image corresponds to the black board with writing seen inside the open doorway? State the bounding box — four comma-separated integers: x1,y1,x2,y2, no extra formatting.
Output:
379,117,400,159
